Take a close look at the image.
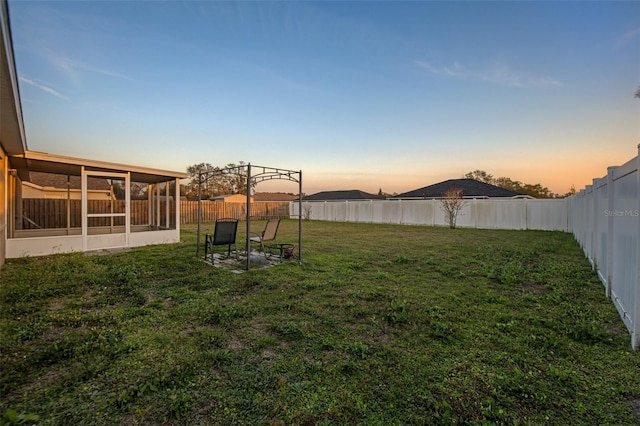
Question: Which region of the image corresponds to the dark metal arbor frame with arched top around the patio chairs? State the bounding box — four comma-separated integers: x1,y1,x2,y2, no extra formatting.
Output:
196,163,302,271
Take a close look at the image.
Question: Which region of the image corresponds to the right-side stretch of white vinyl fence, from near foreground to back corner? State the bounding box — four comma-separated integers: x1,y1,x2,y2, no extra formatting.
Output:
567,145,640,350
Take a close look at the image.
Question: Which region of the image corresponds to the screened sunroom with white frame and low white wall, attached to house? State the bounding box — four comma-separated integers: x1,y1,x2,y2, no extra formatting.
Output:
6,151,187,258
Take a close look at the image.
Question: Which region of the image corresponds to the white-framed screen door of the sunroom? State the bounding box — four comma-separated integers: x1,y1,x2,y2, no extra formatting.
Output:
82,170,131,250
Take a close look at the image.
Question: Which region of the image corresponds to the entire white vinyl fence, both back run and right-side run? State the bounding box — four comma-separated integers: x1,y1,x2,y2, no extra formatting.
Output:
290,145,640,350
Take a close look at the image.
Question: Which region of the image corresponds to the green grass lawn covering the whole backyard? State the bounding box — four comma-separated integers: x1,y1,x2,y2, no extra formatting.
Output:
0,221,640,425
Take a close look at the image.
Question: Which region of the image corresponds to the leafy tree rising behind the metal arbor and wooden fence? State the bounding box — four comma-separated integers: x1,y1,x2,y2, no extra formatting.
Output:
186,161,255,200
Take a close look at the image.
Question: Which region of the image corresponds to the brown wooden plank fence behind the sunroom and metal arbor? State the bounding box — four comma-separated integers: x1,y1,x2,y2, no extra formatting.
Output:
17,198,289,229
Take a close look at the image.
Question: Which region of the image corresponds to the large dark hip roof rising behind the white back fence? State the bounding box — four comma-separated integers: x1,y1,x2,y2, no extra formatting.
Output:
394,179,522,198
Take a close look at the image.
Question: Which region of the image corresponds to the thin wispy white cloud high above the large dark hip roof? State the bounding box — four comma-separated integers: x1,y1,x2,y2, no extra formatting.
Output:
415,60,563,87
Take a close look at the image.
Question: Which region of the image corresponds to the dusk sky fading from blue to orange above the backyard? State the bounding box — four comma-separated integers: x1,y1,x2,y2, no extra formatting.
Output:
9,1,640,194
